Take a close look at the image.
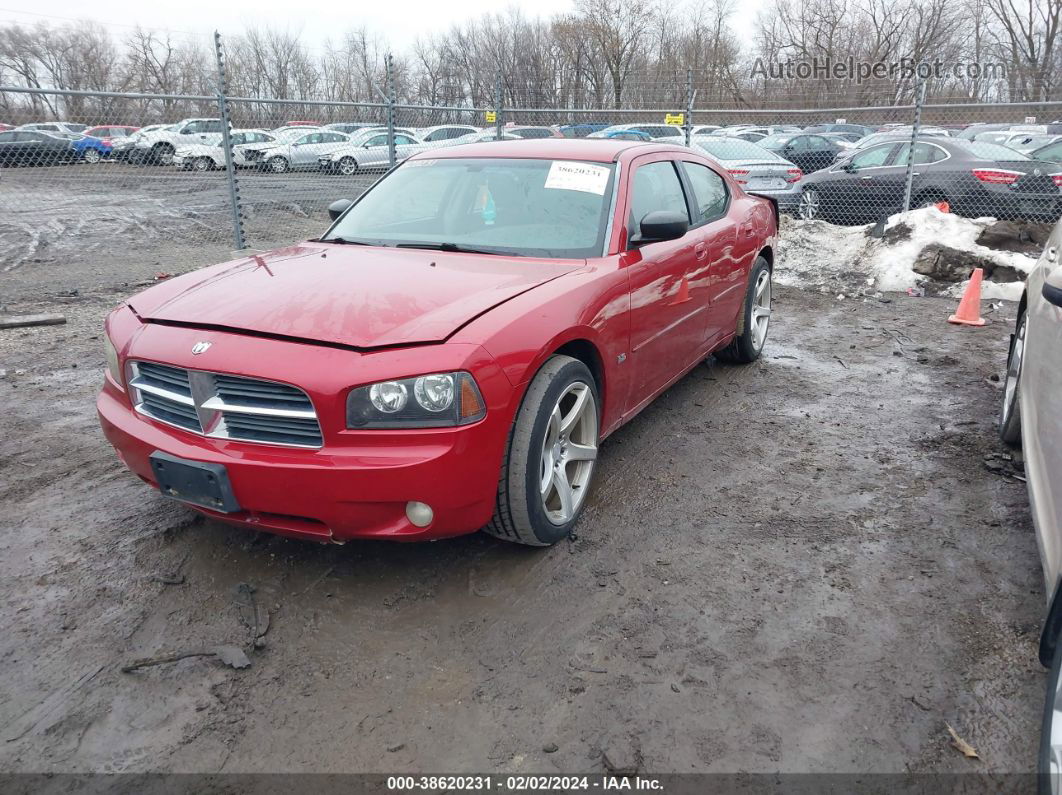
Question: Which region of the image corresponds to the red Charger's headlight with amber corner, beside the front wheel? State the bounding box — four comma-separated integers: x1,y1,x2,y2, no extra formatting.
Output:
346,373,486,429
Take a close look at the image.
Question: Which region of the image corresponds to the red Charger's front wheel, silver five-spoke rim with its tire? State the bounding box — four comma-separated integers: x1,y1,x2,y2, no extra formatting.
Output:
484,356,599,547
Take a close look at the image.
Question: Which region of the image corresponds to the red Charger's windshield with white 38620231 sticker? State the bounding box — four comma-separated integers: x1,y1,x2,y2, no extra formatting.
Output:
324,158,615,259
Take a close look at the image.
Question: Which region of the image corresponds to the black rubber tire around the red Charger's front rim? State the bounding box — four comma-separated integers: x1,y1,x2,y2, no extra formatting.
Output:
483,356,601,547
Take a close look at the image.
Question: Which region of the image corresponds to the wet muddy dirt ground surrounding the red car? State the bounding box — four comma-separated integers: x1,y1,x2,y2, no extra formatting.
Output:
0,167,1045,773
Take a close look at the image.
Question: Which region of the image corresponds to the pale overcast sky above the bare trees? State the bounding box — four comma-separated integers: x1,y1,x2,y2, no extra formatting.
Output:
0,0,764,52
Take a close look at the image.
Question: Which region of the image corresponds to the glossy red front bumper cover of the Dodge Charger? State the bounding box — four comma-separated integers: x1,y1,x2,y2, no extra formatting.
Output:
97,324,515,541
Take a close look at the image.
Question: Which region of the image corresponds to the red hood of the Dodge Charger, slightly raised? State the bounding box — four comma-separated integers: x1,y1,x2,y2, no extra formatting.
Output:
129,242,585,348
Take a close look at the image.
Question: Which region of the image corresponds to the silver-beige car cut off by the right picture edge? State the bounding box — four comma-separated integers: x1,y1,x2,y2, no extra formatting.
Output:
999,214,1062,793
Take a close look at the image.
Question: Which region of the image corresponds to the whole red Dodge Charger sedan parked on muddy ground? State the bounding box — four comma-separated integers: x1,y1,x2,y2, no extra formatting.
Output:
98,139,777,546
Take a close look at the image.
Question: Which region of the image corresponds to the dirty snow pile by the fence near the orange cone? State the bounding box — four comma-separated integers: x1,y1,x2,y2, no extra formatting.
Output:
776,207,1035,300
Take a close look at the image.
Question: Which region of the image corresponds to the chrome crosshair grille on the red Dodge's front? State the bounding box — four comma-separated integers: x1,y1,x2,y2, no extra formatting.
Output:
129,362,323,448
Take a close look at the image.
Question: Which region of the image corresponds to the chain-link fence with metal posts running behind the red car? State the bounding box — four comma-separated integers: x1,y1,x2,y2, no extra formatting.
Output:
0,62,1062,281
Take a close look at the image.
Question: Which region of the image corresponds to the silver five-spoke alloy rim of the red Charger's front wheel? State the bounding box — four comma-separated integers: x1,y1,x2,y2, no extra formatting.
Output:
538,381,598,524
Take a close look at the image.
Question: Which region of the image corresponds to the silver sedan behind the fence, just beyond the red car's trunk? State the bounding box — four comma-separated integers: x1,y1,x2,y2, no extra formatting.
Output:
690,135,804,210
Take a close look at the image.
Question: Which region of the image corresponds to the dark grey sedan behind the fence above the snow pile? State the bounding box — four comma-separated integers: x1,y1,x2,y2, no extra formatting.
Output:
798,137,1062,223
